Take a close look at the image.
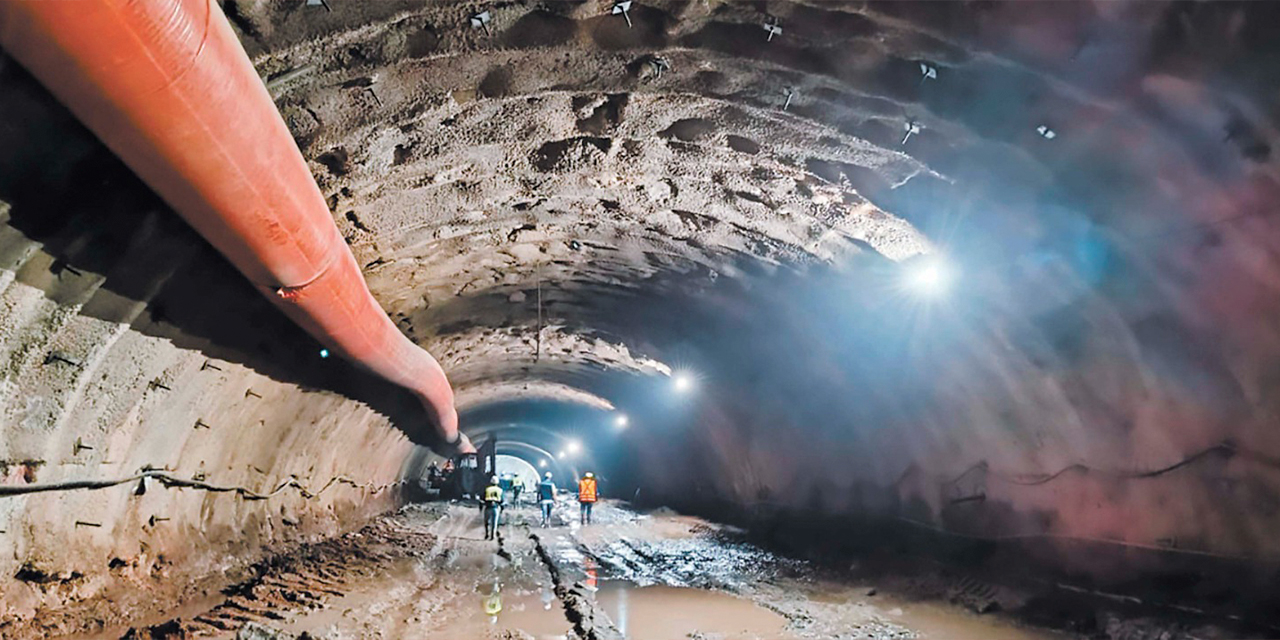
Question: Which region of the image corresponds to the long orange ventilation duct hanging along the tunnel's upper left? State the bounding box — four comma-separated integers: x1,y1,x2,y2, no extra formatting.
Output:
0,0,472,451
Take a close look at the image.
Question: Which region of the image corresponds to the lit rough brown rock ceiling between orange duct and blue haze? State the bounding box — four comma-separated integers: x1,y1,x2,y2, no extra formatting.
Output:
234,3,967,388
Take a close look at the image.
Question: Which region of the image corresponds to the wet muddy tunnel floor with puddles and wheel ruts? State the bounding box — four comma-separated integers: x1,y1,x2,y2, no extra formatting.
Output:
97,503,1249,640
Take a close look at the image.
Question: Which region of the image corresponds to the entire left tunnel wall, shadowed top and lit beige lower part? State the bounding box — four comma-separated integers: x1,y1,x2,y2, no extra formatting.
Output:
0,61,421,637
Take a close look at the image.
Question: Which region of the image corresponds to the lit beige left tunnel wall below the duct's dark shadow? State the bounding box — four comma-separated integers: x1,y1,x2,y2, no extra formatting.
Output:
0,201,412,637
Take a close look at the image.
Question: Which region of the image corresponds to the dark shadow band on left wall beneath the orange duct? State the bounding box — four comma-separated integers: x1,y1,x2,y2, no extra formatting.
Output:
0,58,450,447
